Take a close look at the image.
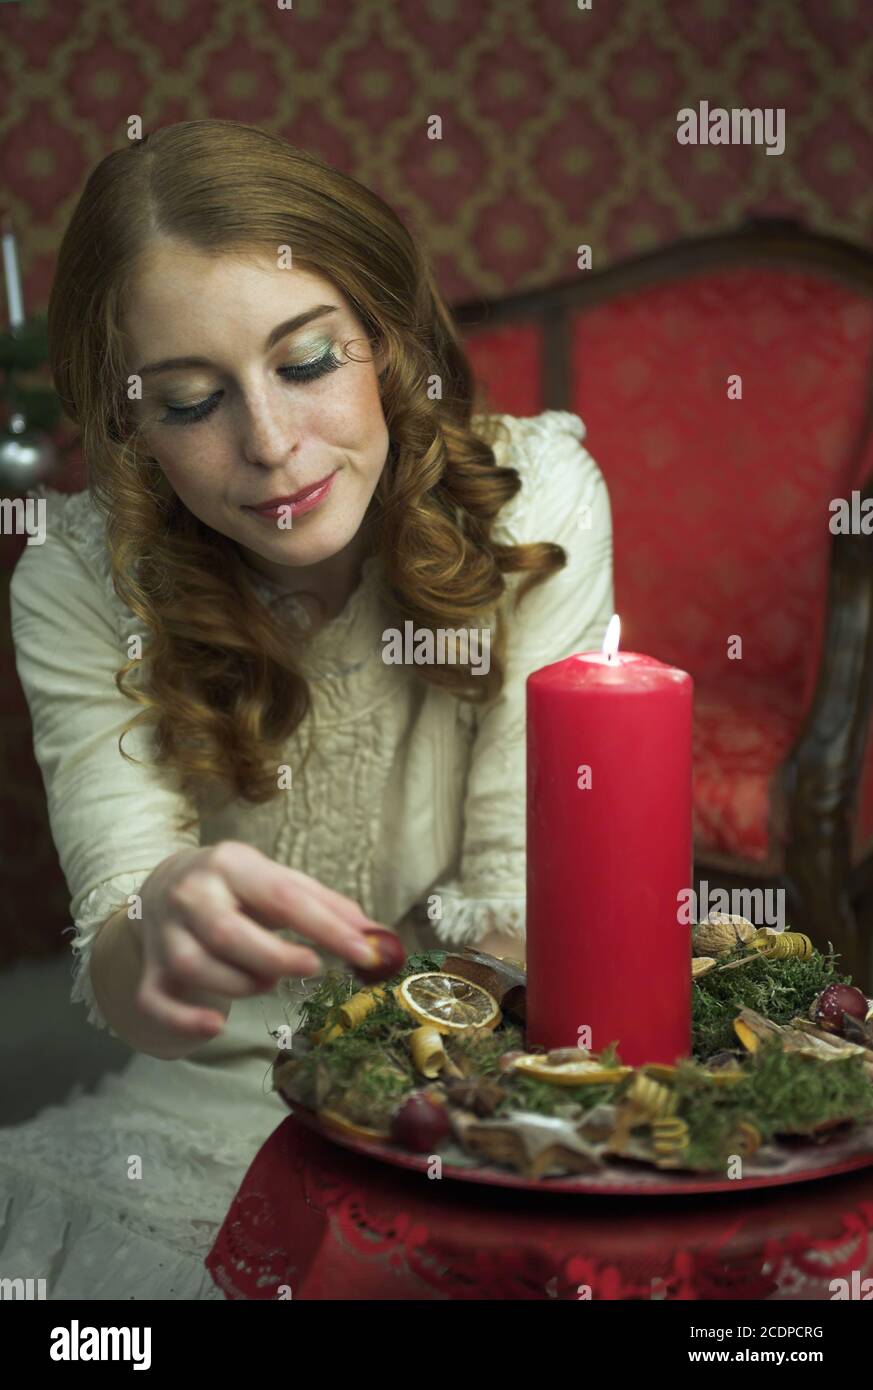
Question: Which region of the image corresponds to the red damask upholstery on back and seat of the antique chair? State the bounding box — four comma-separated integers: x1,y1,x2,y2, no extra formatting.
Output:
573,267,873,874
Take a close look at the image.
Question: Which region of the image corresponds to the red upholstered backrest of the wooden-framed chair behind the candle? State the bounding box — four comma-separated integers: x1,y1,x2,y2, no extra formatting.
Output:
462,234,873,719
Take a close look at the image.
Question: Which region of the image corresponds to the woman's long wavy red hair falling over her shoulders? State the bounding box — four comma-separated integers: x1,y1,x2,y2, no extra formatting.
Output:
49,121,566,824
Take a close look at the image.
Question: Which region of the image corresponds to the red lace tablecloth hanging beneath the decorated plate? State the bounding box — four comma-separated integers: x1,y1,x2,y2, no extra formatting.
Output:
206,1115,873,1300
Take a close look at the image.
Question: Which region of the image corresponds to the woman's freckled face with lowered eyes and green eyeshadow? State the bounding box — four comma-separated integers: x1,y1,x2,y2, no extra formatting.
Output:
122,238,389,578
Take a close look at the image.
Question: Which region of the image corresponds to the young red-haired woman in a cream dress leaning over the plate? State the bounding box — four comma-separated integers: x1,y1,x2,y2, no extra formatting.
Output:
0,121,613,1298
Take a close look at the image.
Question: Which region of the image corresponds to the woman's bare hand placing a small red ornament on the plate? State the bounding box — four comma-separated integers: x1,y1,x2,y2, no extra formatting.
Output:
133,840,386,1038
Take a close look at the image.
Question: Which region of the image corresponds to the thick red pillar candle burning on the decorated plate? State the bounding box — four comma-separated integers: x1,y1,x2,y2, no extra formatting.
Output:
527,619,694,1066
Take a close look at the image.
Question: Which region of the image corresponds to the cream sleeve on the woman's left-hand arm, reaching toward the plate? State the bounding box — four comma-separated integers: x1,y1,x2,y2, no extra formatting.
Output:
10,496,200,1027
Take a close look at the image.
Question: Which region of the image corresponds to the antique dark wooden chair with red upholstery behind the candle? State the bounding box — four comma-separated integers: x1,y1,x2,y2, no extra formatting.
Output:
457,220,873,984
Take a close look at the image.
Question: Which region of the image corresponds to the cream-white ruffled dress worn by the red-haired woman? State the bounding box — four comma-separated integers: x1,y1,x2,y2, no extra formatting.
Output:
0,411,613,1300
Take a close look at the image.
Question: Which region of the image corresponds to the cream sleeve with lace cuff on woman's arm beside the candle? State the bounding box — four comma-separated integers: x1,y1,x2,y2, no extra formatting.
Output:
428,410,613,945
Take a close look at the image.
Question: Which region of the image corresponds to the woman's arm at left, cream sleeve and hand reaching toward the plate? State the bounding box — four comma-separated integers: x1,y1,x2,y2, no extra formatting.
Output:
10,493,374,1058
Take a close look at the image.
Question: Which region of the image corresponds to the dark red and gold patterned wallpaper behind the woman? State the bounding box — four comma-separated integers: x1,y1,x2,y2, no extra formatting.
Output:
0,0,873,309
